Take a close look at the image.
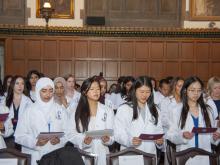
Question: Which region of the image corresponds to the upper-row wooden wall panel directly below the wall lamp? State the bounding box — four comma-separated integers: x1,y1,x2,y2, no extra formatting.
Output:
43,39,58,59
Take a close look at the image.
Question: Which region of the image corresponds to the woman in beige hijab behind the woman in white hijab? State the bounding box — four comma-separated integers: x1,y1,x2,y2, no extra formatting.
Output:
53,77,68,109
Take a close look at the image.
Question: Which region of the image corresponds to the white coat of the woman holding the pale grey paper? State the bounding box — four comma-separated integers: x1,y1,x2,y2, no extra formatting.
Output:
69,103,114,165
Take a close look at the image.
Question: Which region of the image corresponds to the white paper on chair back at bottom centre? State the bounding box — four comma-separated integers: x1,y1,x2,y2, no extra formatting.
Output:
119,155,144,165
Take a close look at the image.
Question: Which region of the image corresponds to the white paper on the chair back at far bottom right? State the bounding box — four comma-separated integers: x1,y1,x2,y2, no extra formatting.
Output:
186,155,209,165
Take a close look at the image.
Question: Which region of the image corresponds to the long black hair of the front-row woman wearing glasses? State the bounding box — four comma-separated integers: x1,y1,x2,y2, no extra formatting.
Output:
179,76,211,129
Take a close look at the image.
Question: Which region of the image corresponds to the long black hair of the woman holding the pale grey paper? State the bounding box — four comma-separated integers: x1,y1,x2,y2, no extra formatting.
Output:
75,76,100,132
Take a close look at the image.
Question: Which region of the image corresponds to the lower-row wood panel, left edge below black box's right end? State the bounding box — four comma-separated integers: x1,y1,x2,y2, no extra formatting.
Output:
104,61,119,79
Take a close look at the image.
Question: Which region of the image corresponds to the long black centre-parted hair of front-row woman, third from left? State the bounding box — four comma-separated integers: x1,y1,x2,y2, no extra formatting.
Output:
128,76,159,125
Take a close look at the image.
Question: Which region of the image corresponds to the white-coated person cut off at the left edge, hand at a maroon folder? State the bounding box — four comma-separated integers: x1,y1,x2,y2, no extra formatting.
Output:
0,104,14,149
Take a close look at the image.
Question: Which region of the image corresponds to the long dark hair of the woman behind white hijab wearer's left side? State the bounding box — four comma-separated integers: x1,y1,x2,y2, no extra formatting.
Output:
6,75,25,108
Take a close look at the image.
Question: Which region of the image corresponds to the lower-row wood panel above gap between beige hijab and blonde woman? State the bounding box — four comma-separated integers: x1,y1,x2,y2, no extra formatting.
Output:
58,60,74,76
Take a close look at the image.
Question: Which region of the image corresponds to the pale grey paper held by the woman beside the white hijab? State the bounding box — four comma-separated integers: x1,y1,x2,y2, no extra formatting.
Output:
85,129,114,138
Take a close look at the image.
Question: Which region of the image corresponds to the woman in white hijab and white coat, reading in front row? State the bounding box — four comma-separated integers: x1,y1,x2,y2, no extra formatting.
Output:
15,77,67,165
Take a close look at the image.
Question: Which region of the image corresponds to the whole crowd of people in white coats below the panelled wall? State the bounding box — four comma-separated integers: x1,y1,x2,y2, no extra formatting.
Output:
0,70,220,165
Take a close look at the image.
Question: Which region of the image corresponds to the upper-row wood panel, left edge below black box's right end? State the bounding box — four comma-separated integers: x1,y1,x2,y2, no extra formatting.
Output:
104,40,119,59
